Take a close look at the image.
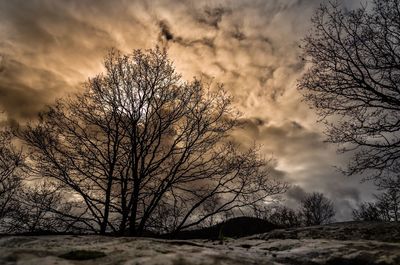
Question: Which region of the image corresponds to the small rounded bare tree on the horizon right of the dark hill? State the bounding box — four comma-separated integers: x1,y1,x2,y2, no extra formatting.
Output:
300,192,335,226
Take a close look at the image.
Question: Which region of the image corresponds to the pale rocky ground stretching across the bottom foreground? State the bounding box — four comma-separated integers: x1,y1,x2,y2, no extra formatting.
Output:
0,223,400,265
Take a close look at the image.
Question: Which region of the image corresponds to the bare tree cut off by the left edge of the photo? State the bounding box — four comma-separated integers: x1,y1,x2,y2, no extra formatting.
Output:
0,128,24,227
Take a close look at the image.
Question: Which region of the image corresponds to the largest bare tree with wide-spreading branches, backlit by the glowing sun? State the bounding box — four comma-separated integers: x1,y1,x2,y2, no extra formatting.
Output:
16,49,286,235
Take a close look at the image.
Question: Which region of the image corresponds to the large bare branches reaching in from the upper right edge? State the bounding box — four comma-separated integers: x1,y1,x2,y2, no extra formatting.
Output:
299,0,400,178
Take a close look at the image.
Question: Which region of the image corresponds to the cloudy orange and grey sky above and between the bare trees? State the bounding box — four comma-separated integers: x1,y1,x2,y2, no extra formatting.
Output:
0,0,374,221
